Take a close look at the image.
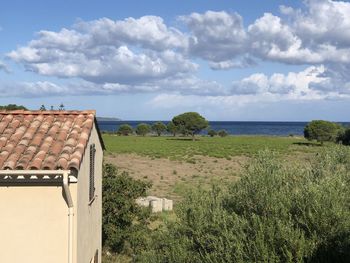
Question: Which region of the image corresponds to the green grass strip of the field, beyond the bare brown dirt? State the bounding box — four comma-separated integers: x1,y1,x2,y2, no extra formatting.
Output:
103,134,319,163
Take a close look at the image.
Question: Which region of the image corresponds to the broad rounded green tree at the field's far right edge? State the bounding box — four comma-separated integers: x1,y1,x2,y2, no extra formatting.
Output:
304,120,343,144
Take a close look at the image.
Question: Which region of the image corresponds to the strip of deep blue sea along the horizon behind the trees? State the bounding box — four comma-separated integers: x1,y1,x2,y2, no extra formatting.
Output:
98,121,318,136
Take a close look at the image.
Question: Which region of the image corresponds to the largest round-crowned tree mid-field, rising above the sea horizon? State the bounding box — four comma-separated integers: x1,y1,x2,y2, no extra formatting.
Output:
172,112,209,140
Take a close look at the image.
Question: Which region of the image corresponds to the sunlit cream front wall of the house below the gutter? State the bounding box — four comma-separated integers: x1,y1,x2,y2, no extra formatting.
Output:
0,182,76,263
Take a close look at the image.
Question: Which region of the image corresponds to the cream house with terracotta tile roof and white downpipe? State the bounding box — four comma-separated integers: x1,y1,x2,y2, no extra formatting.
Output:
0,111,104,263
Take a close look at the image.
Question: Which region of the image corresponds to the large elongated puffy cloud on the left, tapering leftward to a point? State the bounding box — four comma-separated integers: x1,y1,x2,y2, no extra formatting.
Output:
7,16,197,84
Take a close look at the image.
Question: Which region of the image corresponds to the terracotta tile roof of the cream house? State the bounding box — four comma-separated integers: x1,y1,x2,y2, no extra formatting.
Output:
0,110,99,170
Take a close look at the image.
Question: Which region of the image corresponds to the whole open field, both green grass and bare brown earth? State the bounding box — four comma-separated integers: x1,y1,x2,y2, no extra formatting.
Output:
103,134,327,202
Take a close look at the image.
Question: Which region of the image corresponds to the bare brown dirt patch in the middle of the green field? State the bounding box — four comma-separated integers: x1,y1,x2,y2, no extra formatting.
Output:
105,154,249,201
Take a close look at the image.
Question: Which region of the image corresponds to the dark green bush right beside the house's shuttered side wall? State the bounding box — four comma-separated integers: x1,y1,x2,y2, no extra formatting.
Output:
102,164,150,254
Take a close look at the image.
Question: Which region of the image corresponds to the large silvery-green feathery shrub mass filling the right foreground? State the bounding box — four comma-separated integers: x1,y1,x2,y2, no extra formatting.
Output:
140,146,350,263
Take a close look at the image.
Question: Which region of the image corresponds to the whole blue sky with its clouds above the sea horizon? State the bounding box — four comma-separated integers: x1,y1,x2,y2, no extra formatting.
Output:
0,0,350,121
